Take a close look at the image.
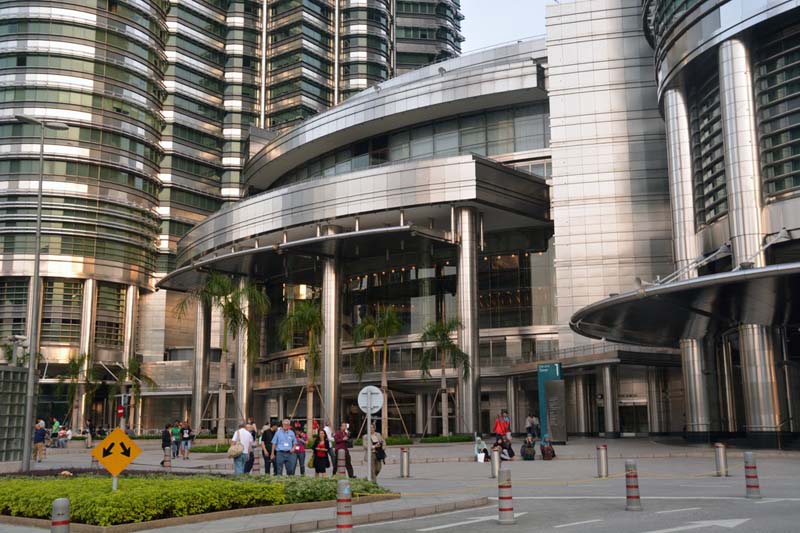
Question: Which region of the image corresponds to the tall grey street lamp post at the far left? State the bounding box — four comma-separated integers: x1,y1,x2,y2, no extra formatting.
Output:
15,115,69,473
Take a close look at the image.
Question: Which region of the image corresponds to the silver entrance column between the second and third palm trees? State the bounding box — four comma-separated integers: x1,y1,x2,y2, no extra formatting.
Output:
320,226,342,428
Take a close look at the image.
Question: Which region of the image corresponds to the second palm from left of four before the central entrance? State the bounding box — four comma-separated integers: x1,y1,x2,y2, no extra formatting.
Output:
278,300,322,429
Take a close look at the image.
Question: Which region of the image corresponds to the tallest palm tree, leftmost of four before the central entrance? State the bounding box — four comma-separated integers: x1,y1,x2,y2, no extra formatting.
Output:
175,271,270,440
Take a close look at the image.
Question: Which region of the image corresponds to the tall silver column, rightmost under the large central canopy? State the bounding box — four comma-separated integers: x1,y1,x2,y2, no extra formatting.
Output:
456,207,480,433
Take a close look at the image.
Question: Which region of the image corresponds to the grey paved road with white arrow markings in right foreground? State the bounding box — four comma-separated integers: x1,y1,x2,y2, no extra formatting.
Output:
338,455,800,533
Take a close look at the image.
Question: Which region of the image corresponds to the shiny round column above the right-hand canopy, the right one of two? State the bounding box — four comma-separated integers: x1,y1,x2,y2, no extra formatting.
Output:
719,38,764,267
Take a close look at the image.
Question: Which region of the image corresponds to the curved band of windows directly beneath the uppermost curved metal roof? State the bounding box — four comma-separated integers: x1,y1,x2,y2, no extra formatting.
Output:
274,105,550,187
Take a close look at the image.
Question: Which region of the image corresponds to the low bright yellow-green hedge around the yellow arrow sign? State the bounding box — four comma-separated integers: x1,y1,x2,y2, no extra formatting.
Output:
0,475,387,526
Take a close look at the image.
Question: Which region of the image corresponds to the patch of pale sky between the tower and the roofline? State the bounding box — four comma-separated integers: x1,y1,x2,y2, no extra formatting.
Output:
461,0,553,53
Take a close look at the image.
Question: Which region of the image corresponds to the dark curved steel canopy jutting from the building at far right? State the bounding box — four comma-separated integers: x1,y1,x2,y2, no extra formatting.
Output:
570,262,800,347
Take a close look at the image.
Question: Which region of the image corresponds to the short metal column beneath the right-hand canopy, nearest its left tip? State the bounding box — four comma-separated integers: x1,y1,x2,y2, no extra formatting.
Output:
680,339,711,439
